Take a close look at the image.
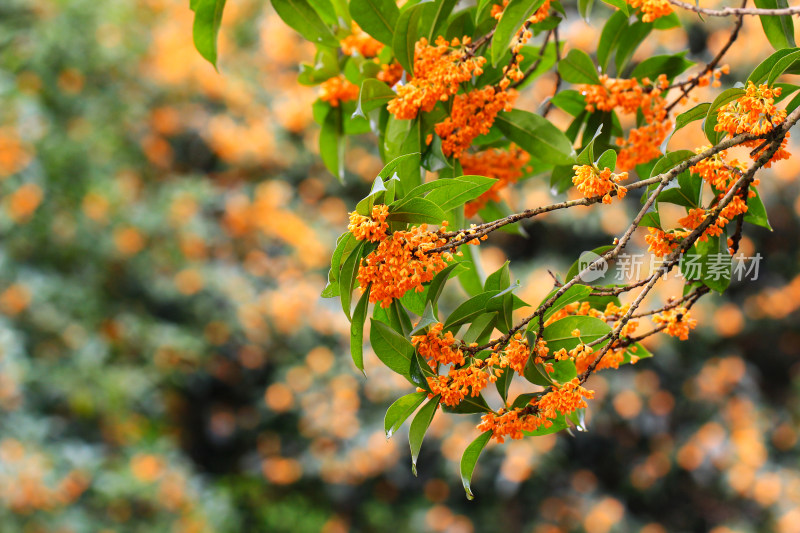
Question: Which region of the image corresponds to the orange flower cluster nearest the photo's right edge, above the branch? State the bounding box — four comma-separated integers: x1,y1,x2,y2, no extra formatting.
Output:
714,81,791,168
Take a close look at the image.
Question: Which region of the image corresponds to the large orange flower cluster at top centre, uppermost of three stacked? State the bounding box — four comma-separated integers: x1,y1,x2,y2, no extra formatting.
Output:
387,37,486,120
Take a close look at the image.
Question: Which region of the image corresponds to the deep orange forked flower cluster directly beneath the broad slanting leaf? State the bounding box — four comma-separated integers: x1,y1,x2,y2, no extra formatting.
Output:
461,144,530,217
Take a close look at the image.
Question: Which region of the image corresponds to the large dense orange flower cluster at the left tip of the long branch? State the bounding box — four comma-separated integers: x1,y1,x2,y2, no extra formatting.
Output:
358,222,452,307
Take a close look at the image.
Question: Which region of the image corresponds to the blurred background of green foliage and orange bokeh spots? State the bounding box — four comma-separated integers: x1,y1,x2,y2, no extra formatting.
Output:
0,0,800,533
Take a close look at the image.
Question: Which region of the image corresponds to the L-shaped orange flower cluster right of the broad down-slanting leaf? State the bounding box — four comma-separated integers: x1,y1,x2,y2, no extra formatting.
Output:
579,74,672,170
